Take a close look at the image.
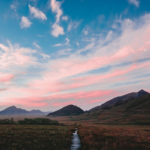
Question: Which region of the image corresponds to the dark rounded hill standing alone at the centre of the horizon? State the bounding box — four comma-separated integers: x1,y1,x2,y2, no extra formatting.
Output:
47,105,84,116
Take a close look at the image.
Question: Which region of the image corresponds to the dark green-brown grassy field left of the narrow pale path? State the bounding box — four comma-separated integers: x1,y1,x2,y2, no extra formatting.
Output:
0,125,74,150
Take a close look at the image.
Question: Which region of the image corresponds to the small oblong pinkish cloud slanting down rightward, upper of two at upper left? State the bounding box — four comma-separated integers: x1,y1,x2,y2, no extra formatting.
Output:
29,5,47,20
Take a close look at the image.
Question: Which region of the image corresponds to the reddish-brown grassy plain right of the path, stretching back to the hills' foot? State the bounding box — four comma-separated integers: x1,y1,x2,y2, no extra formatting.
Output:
48,114,150,150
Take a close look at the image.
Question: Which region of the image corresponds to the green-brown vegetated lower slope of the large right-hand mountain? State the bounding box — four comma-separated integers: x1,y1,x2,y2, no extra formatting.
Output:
73,94,150,125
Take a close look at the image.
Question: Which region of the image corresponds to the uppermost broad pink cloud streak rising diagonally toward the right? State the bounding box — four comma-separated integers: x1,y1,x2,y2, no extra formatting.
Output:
30,40,146,89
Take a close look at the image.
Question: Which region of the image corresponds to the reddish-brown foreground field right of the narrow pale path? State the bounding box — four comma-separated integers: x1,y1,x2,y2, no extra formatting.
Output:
79,126,150,150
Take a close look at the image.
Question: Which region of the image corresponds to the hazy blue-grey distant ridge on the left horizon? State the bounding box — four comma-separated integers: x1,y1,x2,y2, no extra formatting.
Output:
0,106,49,115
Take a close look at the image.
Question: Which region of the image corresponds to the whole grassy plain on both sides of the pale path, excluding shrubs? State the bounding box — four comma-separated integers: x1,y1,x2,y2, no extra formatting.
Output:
0,116,150,150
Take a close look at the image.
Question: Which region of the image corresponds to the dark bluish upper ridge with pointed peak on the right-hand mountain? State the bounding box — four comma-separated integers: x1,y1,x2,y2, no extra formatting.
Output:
89,89,149,112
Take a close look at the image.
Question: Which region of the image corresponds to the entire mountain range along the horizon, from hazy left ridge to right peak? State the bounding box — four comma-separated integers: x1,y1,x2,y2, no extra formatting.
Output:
0,90,150,123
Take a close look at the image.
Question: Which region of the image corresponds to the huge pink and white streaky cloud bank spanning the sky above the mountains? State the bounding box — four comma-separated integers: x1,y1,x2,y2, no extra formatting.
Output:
0,10,150,107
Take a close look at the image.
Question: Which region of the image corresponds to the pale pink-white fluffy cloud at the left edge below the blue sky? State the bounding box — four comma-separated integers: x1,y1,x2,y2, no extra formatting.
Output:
0,41,37,68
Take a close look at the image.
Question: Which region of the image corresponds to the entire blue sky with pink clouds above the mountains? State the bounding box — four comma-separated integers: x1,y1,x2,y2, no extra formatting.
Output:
0,0,150,111
